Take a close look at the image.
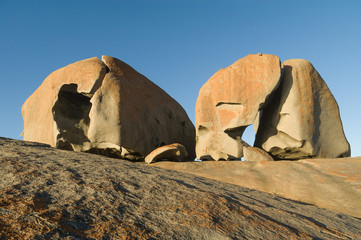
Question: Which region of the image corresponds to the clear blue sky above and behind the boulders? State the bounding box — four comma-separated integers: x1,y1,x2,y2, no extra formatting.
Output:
0,0,361,156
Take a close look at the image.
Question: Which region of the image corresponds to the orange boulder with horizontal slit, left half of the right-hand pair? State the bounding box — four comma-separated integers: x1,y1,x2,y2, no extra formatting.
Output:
196,54,281,160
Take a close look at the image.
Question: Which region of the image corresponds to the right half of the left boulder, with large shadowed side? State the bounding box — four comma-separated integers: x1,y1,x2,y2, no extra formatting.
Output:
88,56,195,160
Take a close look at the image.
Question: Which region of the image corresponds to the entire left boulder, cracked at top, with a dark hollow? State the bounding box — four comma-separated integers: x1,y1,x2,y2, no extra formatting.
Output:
22,56,195,159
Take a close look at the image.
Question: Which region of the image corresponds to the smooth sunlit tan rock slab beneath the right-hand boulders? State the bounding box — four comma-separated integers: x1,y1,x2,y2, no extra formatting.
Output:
153,157,361,218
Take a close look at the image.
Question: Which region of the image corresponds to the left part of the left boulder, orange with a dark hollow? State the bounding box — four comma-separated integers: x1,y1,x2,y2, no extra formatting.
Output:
21,57,106,146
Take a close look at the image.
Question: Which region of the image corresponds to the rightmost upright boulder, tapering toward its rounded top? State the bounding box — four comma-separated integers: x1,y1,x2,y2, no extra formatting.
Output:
255,59,350,159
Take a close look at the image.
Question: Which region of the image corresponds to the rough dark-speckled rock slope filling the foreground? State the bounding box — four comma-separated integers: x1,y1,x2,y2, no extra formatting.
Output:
0,138,361,240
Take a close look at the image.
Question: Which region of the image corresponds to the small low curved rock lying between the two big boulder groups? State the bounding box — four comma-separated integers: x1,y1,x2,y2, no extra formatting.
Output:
145,143,188,163
